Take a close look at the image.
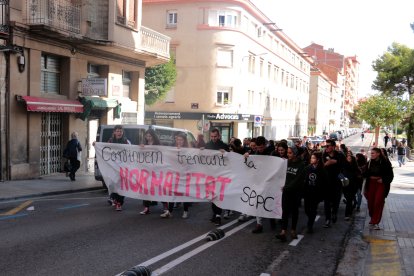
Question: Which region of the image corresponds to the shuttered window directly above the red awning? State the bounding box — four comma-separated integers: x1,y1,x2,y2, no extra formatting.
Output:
40,55,60,94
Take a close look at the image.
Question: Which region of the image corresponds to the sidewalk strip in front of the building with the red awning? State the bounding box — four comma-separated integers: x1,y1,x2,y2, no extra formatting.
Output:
0,172,102,201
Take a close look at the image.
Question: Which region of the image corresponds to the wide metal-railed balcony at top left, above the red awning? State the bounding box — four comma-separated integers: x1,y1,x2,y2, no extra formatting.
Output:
25,0,81,34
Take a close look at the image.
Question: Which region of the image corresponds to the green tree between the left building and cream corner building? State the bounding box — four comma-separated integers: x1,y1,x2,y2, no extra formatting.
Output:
145,57,177,105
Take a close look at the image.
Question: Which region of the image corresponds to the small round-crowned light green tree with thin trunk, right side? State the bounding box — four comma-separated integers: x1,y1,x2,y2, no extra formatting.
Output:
356,94,406,145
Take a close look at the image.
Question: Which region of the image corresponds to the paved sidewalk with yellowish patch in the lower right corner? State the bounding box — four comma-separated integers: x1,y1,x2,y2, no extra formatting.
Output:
336,158,414,276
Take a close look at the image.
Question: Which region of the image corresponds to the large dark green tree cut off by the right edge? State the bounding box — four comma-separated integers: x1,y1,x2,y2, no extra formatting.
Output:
372,42,414,146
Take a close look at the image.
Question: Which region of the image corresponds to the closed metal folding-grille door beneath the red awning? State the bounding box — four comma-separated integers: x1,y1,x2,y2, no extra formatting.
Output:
40,113,62,175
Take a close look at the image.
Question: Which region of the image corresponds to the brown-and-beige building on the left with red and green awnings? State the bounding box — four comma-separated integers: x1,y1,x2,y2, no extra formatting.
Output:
0,0,170,180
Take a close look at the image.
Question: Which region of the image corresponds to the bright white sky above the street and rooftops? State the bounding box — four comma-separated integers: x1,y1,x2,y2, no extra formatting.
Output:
250,0,414,97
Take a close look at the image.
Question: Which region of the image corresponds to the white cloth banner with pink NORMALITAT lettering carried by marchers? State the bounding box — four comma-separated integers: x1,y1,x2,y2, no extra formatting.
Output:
95,143,287,218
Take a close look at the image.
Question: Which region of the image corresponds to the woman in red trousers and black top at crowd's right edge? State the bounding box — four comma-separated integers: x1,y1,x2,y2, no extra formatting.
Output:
364,148,394,230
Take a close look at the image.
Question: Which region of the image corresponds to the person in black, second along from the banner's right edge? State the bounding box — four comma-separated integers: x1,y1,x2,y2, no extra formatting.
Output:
304,152,327,233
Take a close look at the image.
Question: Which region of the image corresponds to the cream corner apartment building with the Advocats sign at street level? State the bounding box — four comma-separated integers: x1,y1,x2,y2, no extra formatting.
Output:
142,0,312,142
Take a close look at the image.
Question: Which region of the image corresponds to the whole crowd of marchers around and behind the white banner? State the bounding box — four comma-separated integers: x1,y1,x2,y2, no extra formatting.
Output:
100,128,398,241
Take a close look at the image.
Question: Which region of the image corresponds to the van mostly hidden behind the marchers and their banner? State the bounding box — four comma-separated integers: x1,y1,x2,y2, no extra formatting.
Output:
95,125,196,188
